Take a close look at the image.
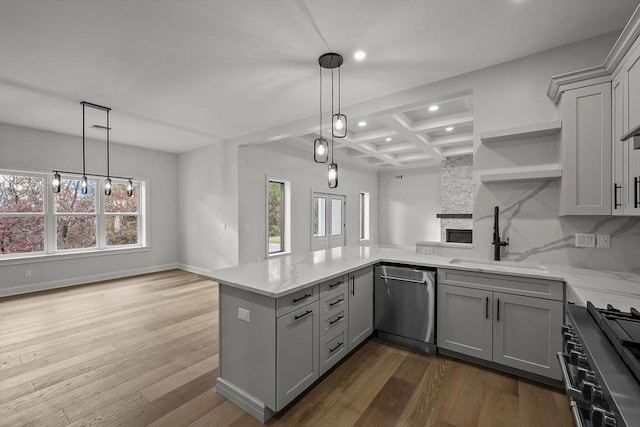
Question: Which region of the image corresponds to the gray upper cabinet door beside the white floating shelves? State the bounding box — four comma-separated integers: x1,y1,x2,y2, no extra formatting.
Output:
560,81,612,215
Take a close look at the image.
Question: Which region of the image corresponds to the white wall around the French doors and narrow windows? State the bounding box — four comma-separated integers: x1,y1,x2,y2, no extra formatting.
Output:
238,143,378,264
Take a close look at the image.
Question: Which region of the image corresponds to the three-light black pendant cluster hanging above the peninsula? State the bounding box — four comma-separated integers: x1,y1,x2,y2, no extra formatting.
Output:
313,52,347,188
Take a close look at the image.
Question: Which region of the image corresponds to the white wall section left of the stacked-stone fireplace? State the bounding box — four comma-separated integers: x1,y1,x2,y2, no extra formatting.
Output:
378,167,441,246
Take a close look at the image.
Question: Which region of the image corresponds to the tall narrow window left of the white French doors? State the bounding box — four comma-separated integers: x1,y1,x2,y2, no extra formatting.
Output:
267,179,290,255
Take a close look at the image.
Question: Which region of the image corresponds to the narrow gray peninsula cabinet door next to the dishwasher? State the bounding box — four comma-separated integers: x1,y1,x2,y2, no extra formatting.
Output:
348,267,373,351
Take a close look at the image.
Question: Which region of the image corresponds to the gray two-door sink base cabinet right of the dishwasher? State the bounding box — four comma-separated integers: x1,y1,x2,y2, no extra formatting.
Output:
437,269,564,380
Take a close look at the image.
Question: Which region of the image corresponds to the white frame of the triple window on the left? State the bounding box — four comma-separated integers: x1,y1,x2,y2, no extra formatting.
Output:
0,166,150,264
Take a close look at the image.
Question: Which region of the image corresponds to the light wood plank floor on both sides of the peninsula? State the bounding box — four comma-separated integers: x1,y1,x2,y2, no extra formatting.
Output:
0,270,572,427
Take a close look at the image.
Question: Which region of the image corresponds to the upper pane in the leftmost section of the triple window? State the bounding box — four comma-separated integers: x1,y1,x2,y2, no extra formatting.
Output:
0,175,44,212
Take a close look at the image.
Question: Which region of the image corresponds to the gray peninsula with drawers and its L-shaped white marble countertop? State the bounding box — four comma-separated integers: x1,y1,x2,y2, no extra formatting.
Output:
210,246,640,422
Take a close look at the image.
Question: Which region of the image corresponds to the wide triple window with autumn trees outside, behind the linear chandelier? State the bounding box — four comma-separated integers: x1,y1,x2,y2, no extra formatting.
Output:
0,171,144,258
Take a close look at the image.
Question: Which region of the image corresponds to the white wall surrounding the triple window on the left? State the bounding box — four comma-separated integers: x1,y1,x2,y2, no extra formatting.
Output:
0,123,178,295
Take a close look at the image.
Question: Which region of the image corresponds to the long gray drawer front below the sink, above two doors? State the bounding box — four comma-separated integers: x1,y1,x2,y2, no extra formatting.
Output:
438,268,564,301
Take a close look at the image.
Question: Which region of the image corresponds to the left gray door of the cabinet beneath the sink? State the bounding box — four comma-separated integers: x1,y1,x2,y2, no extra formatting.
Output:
437,284,493,361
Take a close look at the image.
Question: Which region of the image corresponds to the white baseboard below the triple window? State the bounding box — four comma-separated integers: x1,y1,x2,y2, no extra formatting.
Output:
0,263,181,297
